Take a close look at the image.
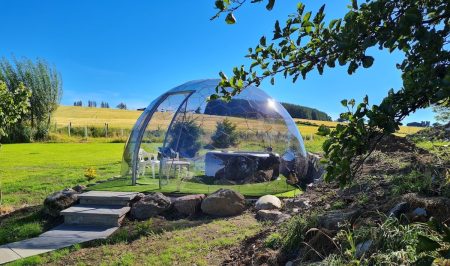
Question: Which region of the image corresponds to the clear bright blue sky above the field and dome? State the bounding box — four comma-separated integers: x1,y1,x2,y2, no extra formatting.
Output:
0,0,434,122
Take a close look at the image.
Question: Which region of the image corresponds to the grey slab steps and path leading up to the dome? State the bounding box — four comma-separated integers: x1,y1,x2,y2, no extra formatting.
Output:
0,191,137,264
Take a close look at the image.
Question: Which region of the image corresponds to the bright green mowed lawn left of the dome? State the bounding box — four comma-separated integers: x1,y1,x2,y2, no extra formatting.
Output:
0,143,124,208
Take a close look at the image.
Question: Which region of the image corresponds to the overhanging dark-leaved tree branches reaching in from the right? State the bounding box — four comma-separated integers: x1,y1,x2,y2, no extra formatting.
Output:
211,0,450,185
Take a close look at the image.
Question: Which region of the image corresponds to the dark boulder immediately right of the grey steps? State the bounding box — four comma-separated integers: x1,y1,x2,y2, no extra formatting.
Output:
130,192,172,220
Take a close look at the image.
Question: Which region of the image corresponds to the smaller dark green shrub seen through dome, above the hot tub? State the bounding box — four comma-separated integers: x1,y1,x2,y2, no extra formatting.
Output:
211,118,238,148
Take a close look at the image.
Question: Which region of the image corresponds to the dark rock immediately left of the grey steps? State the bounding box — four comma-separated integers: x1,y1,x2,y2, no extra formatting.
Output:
44,188,78,217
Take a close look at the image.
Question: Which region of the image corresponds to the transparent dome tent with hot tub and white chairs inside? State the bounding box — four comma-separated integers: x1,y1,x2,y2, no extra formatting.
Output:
121,79,308,196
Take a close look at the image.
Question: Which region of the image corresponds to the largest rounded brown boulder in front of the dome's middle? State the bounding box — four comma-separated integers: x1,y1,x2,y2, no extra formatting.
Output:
201,188,245,216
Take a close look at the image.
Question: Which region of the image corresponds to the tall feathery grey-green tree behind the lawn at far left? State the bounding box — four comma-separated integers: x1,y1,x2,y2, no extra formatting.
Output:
0,58,62,143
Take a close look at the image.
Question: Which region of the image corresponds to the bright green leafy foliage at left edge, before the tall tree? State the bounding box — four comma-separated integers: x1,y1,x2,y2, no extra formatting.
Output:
0,80,31,137
